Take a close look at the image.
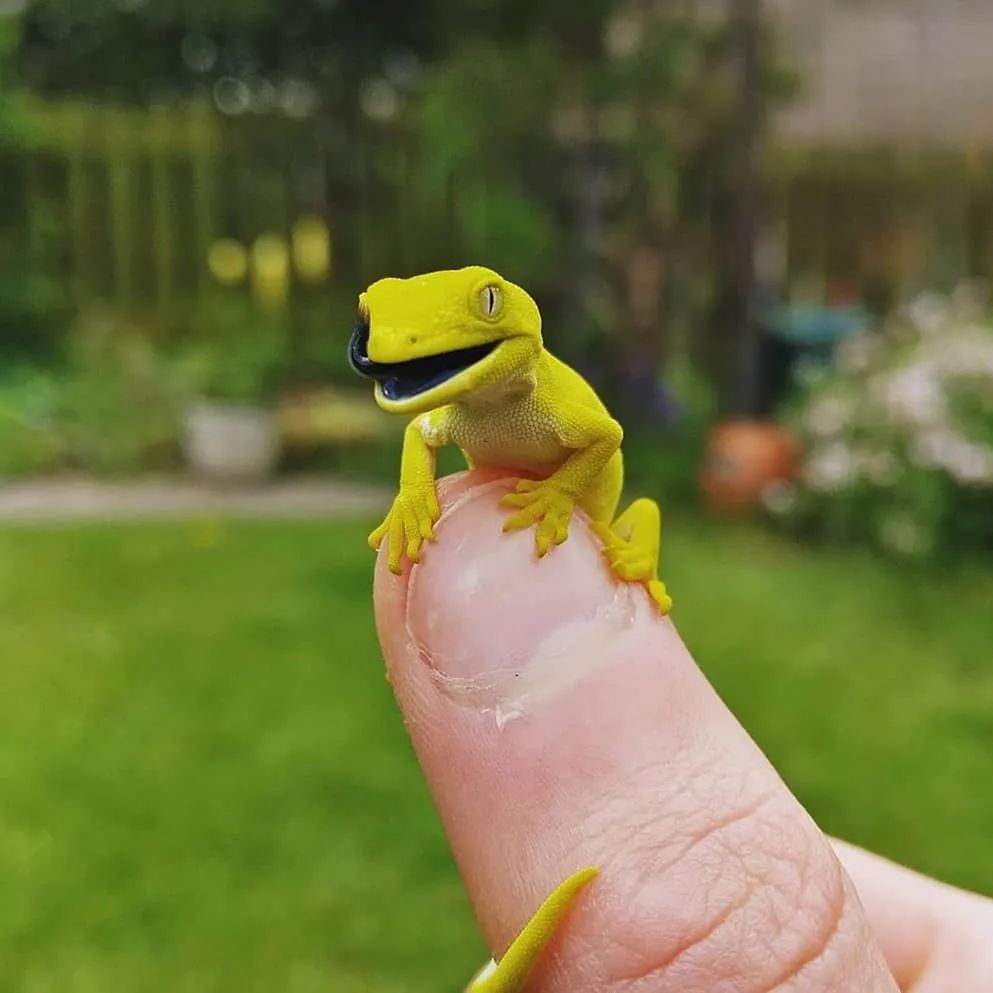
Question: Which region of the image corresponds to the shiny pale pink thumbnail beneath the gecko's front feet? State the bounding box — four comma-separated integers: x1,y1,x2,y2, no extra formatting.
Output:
407,482,647,720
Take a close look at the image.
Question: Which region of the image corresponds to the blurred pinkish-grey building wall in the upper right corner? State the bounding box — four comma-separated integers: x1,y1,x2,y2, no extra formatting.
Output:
766,0,993,146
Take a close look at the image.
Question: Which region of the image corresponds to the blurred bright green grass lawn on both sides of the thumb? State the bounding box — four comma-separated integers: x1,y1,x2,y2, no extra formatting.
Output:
0,520,993,993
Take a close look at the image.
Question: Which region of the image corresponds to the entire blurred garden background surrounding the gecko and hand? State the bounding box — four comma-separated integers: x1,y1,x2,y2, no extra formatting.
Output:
0,0,993,993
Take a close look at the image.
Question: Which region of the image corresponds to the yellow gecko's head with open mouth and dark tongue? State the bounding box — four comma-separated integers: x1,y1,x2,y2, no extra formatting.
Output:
349,266,542,414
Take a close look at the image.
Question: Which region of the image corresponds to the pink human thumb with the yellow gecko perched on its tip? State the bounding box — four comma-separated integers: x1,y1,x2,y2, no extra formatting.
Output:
376,474,897,993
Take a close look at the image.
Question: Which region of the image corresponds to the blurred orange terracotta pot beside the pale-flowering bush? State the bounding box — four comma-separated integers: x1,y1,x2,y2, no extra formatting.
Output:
700,421,797,513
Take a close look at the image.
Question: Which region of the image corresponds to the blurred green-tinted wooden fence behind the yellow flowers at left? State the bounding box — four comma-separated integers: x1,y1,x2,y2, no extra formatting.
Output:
0,96,346,324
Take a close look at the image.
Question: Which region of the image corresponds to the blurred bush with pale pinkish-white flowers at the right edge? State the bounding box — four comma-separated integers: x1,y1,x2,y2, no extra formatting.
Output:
765,291,993,558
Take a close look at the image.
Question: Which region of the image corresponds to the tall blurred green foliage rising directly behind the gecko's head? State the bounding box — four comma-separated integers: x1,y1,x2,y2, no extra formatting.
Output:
402,2,784,418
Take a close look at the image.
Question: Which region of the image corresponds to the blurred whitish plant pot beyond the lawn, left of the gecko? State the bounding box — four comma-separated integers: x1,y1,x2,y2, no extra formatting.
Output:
184,401,280,483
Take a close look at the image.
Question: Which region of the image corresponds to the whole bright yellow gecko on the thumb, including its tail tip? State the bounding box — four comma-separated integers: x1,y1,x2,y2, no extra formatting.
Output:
349,266,672,993
